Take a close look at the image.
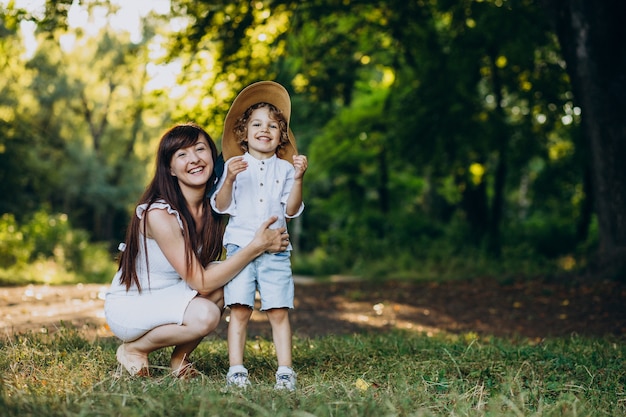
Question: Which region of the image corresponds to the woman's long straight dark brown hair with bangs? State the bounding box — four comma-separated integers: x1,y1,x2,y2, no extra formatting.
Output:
119,123,224,291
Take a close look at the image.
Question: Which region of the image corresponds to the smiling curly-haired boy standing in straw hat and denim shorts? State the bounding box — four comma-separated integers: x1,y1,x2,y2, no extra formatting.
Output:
211,81,307,391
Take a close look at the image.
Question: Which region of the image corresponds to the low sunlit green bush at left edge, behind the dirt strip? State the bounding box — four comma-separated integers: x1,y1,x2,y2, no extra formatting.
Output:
0,210,115,285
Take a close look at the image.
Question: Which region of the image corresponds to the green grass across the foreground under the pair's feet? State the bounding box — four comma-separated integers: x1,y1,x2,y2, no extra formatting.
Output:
0,328,626,417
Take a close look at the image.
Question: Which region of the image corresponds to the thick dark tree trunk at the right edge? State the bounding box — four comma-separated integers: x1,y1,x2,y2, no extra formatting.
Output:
543,0,626,279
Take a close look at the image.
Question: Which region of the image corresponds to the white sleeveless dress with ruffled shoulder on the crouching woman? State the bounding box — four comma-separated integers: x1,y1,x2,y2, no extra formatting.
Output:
104,200,198,342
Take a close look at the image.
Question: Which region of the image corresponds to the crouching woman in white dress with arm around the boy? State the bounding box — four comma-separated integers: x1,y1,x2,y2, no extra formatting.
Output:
104,124,289,377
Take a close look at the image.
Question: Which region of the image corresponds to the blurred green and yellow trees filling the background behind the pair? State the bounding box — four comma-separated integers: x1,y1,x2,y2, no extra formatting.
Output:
0,0,626,278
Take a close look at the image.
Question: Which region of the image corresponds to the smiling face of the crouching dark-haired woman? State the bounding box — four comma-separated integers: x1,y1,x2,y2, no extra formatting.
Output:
170,135,213,187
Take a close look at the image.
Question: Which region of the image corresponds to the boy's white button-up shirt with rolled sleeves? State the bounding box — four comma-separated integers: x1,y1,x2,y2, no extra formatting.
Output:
210,152,304,250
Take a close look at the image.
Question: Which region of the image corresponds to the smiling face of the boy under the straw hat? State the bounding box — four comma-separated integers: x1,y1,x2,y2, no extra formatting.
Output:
246,107,280,159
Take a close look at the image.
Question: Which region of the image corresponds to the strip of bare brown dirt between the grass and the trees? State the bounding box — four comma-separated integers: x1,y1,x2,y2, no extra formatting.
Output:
0,278,626,339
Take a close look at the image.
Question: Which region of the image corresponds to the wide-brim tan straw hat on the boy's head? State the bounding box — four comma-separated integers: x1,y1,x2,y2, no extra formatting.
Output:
222,81,298,164
